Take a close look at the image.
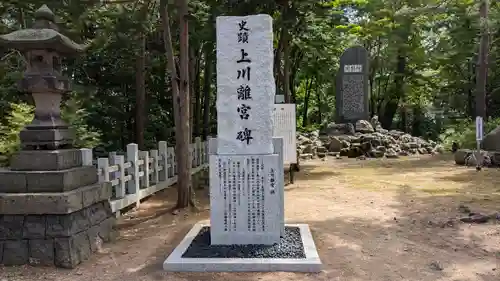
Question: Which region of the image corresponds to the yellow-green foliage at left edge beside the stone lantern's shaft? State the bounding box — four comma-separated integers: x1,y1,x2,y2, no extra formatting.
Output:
0,103,33,166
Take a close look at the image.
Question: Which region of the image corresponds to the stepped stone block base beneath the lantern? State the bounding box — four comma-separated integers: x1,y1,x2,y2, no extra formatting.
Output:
0,149,115,268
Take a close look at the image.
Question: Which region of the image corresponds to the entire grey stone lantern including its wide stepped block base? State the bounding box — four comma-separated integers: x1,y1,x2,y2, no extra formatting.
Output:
0,5,114,268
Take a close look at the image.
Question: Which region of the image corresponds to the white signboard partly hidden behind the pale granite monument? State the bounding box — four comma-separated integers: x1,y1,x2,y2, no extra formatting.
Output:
273,103,297,165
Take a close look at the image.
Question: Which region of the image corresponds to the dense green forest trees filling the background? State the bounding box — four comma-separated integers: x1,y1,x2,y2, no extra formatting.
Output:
0,0,500,159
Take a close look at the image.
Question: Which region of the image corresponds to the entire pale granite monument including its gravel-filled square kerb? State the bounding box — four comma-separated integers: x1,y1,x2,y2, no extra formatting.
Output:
163,15,321,272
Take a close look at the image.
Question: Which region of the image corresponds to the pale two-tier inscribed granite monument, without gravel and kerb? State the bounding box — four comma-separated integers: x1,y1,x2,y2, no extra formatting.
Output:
210,15,284,245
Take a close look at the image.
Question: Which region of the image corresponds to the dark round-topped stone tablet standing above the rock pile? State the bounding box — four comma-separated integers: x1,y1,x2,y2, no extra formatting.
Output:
335,46,370,124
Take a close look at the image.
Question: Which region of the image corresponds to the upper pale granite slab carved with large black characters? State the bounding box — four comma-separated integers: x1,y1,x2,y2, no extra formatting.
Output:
216,15,275,155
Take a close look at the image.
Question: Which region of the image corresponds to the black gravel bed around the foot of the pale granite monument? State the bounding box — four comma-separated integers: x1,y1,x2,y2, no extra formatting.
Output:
182,226,306,259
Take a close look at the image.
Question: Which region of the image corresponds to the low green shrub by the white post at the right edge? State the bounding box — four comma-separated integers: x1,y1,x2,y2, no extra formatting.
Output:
439,118,500,149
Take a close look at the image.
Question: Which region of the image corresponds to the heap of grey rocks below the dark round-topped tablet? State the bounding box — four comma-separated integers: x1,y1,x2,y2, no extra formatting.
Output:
297,116,443,159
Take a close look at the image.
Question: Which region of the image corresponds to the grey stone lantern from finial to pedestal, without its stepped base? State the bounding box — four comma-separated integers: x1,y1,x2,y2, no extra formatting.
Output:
0,5,86,150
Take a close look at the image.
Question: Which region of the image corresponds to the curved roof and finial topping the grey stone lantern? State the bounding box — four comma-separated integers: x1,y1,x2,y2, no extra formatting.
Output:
0,5,88,56
